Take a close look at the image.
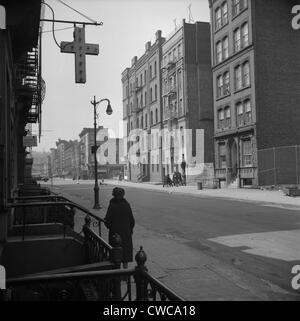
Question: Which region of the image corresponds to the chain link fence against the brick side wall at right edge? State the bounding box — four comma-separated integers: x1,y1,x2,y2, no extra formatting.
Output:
258,145,300,186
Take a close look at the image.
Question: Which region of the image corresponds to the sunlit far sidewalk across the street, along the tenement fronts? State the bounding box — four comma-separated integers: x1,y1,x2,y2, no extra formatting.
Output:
99,180,300,210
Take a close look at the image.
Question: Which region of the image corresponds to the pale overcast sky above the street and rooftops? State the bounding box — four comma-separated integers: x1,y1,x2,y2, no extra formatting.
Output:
34,0,209,151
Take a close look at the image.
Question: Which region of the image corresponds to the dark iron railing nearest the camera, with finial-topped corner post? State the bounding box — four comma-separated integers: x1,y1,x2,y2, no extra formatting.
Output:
3,248,184,301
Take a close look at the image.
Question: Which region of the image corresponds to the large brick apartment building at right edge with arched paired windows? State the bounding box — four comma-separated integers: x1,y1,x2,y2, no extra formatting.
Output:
209,0,300,186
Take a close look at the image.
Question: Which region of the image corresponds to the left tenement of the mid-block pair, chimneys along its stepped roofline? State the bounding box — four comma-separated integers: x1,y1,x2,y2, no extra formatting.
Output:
122,30,165,181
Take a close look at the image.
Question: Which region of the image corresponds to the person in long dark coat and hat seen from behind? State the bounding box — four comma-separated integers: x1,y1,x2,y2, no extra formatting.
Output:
105,187,135,268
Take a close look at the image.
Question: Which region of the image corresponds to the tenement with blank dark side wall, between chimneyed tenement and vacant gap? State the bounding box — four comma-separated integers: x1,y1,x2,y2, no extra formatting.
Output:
161,19,213,181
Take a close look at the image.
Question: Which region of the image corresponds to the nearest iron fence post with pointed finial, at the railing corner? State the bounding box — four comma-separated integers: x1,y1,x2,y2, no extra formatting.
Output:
134,246,148,301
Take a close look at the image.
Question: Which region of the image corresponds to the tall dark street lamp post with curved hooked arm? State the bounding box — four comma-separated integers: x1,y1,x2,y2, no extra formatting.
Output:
91,96,112,209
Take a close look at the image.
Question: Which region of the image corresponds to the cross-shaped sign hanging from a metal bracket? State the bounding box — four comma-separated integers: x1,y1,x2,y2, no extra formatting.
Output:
60,27,99,84
